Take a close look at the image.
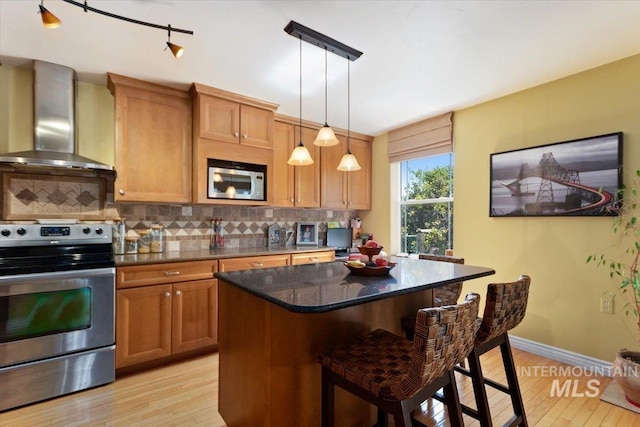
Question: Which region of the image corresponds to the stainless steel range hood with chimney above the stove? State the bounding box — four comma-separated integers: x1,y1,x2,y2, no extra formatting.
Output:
0,60,113,171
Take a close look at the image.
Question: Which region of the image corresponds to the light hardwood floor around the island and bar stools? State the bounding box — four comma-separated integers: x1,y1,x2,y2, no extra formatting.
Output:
0,349,640,427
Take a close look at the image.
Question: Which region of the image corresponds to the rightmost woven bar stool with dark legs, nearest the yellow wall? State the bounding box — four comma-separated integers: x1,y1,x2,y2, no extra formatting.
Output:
455,275,531,427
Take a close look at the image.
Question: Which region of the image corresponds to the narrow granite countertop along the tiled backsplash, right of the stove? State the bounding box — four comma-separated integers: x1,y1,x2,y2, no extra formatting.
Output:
114,246,335,267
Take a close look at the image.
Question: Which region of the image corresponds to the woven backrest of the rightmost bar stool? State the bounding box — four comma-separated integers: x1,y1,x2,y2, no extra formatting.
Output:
476,275,531,344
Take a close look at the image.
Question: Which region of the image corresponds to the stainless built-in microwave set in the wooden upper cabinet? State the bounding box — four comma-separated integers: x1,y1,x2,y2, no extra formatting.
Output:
207,159,267,201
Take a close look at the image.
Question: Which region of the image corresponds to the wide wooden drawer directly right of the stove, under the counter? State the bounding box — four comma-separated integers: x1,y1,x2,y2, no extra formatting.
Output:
116,260,218,289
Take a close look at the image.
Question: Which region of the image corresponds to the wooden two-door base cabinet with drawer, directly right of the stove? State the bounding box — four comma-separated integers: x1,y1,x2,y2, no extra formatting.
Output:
116,261,218,368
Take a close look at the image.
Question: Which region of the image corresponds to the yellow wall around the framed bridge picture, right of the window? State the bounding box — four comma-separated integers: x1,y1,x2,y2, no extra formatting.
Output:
454,55,640,360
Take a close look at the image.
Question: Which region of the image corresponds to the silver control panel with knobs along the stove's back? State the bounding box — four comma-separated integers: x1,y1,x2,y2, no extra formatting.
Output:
0,224,112,247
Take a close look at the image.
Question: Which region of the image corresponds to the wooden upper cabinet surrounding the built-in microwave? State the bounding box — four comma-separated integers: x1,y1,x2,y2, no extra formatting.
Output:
191,83,278,205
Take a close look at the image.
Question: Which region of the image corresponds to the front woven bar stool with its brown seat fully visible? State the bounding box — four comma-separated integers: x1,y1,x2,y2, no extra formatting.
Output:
318,294,480,427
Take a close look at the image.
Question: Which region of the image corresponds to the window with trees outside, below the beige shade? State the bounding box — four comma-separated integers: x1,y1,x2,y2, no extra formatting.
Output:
397,153,453,254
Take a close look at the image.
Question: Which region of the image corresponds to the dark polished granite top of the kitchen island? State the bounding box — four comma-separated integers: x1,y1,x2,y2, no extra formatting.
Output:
215,257,495,313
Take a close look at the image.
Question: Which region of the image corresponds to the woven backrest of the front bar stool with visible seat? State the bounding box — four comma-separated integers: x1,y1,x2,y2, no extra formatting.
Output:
398,293,480,396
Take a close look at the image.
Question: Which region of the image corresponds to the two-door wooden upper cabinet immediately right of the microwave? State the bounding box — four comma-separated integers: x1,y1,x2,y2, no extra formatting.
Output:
269,121,321,208
